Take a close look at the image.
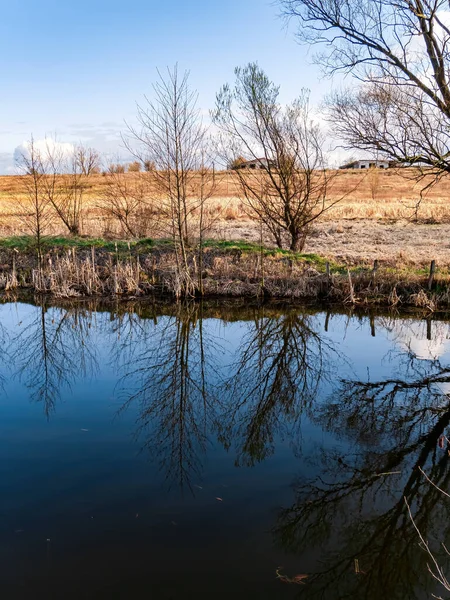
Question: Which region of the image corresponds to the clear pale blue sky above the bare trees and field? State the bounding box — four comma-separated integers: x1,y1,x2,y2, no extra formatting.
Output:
0,0,340,173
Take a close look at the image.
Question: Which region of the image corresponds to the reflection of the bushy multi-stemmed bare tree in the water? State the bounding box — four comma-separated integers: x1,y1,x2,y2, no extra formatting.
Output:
221,309,337,466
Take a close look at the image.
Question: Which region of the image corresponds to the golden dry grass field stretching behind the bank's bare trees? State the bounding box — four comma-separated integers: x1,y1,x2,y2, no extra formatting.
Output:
0,169,450,267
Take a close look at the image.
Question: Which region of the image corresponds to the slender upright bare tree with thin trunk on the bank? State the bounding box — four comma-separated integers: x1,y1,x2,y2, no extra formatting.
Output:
124,66,214,293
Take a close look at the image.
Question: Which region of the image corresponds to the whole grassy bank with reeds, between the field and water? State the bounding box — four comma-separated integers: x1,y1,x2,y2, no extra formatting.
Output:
0,237,450,311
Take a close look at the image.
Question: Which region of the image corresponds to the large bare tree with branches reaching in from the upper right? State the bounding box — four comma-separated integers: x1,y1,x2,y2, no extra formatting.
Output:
279,0,450,176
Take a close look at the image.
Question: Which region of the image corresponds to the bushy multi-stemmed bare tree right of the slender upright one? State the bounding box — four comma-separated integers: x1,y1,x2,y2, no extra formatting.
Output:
213,63,337,251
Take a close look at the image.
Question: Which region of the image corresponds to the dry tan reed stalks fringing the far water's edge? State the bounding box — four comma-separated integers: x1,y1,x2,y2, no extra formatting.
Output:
5,241,450,310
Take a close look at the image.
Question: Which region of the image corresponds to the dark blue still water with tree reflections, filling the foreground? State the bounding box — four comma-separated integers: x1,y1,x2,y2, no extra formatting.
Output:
0,304,450,600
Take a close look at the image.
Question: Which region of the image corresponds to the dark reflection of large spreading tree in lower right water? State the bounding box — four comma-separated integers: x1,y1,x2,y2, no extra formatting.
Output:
274,322,450,599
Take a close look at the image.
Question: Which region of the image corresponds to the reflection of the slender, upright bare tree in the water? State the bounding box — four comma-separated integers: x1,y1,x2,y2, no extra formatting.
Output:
118,303,225,490
